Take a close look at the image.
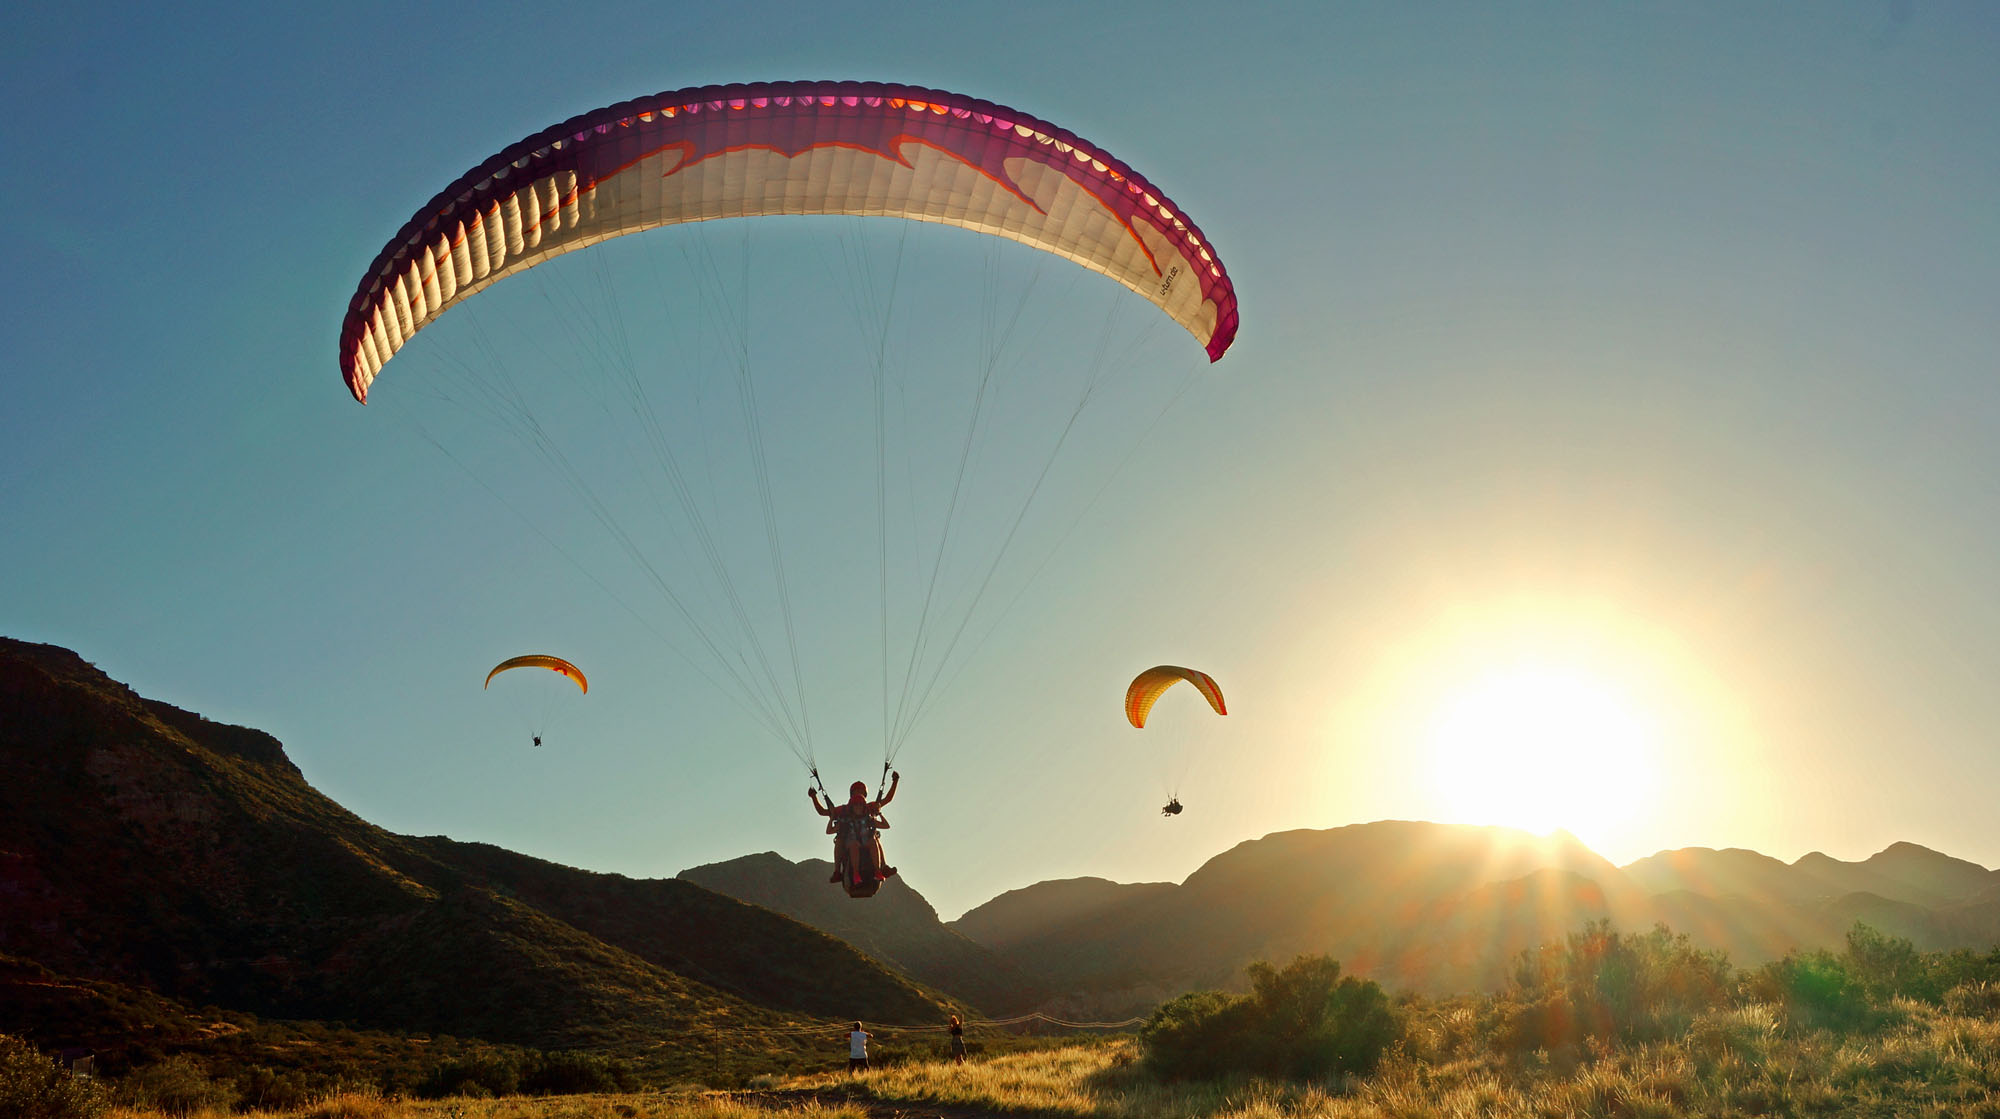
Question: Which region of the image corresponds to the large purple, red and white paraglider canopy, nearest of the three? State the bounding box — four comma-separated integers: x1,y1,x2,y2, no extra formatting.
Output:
340,82,1236,402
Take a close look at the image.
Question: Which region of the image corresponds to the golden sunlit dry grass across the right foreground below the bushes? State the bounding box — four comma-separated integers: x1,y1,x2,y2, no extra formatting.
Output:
782,1003,2000,1119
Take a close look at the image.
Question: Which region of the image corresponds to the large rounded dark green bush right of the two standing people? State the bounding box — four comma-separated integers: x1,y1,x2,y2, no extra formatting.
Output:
1140,955,1402,1079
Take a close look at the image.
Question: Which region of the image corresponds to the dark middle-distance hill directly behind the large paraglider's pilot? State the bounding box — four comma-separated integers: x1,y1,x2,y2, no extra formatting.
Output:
680,851,1046,1015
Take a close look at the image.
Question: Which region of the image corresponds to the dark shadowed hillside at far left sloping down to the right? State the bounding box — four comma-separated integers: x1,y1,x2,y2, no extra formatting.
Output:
0,639,944,1049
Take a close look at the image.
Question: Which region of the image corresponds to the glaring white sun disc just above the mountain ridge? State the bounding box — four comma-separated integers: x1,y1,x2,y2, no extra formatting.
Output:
1426,663,1660,845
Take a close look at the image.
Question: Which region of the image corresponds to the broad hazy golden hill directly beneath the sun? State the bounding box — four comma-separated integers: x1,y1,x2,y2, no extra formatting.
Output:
982,821,1644,1013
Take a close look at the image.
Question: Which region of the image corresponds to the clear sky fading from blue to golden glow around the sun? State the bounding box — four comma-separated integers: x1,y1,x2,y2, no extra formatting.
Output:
0,0,2000,917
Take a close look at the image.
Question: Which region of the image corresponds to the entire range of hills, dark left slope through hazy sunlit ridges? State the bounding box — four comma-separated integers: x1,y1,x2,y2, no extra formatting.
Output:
15,639,2000,1061
